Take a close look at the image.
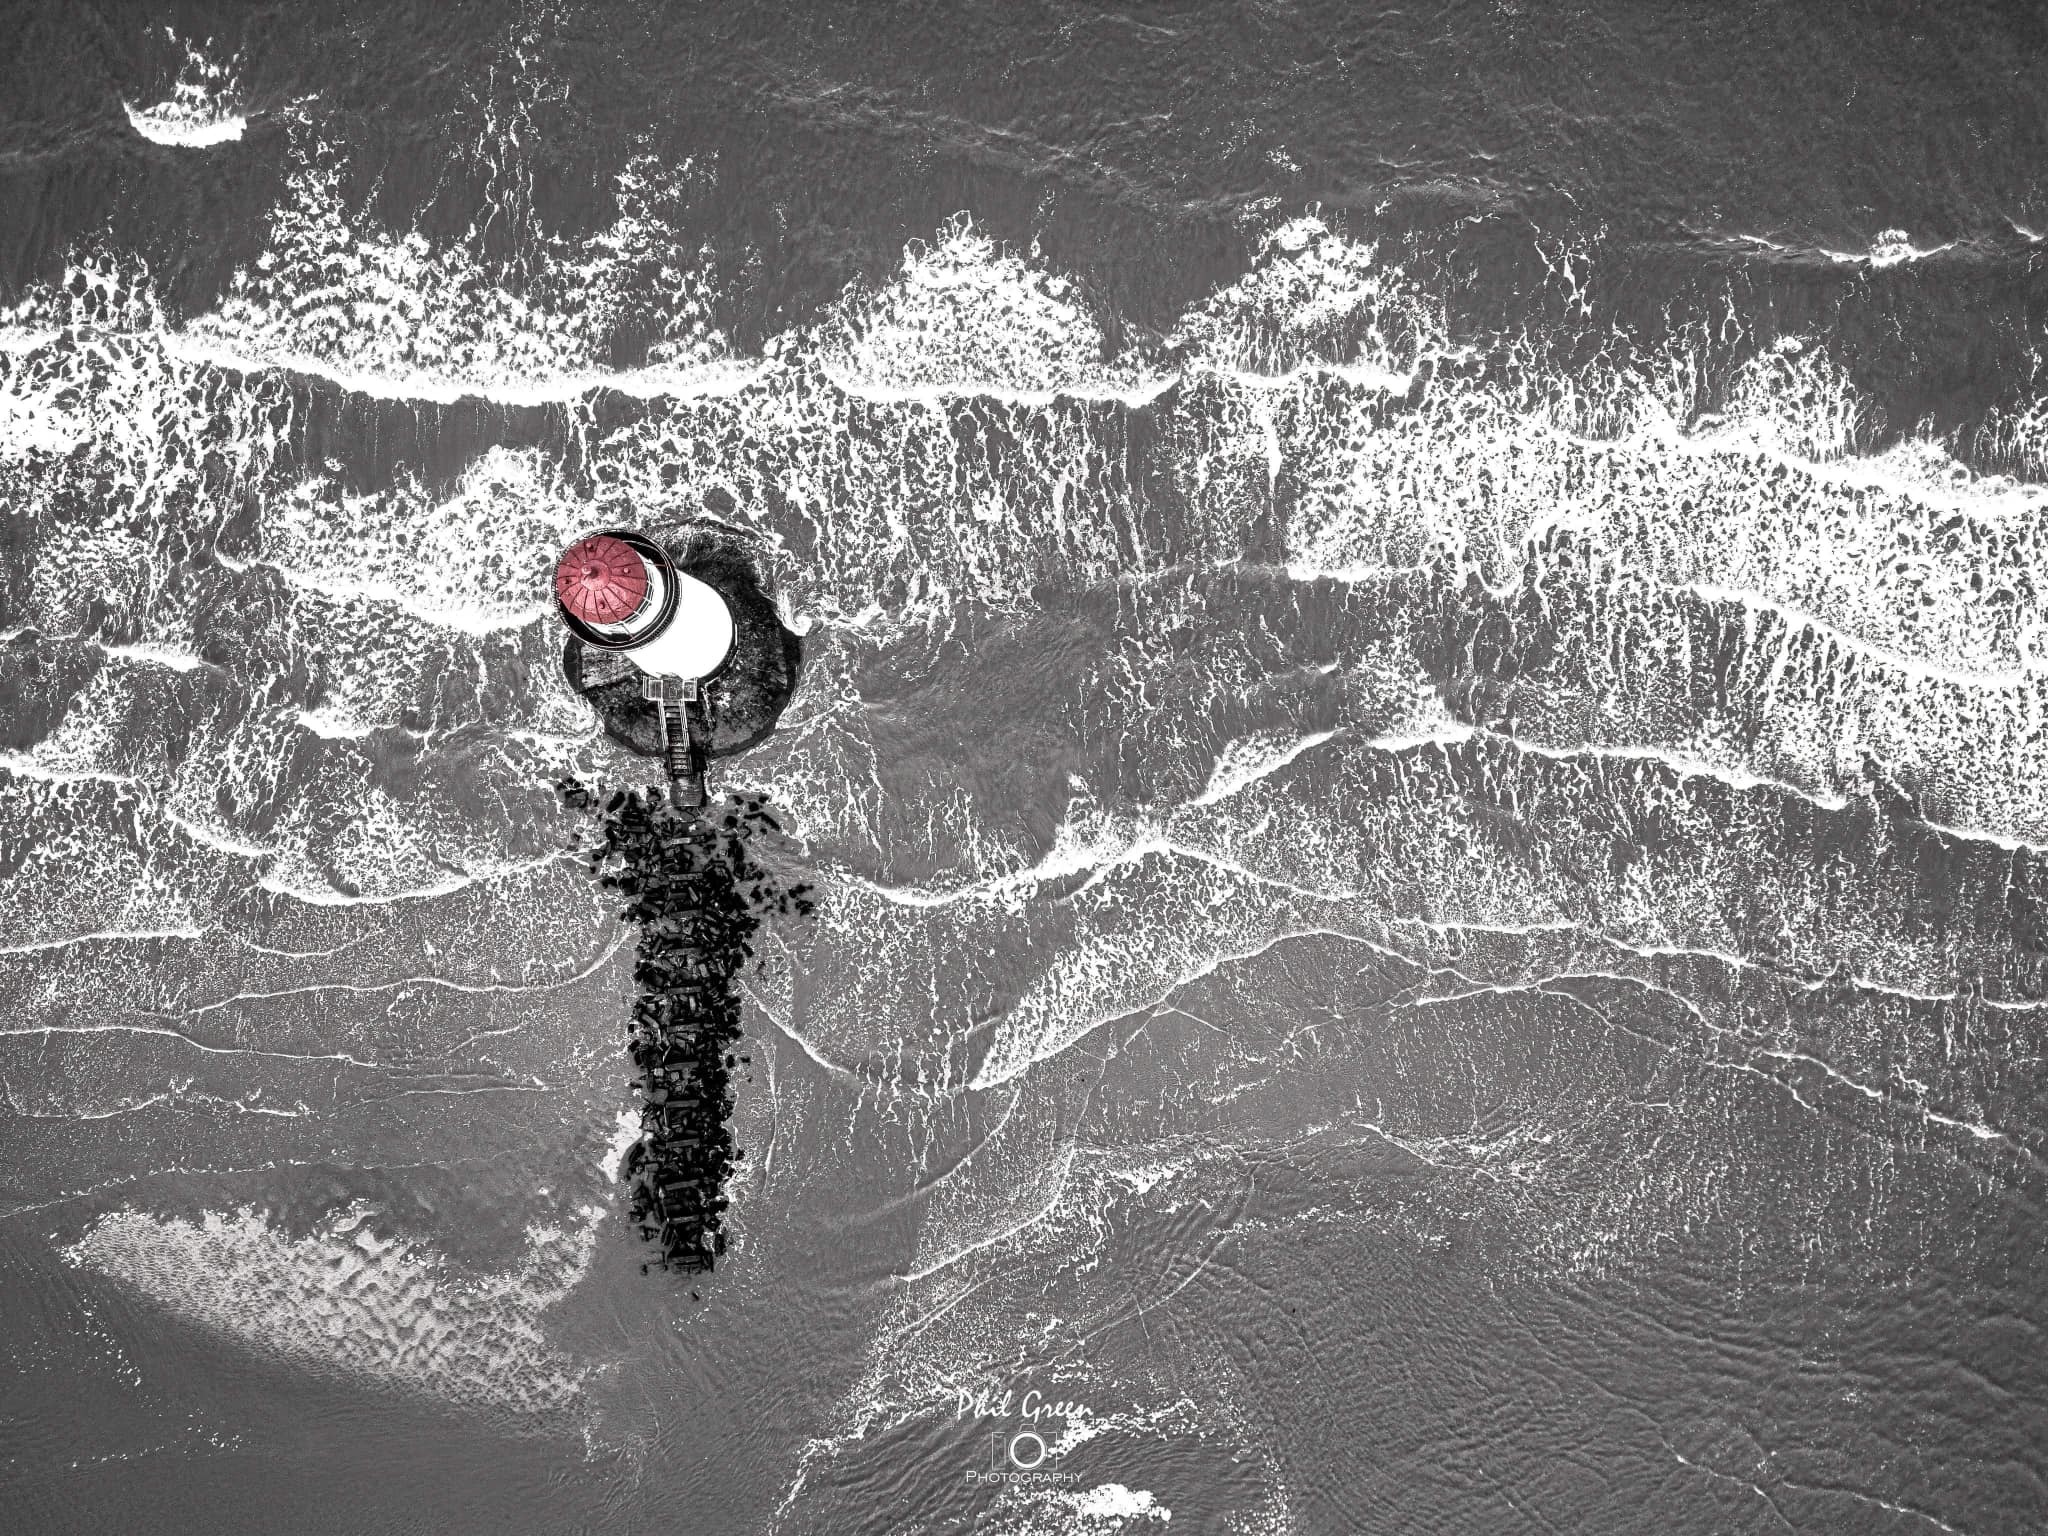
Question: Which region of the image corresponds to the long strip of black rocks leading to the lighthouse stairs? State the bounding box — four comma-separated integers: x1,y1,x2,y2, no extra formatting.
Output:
561,780,811,1272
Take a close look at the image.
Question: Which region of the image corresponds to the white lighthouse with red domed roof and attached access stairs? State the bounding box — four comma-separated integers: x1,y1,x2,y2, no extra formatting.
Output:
555,530,737,805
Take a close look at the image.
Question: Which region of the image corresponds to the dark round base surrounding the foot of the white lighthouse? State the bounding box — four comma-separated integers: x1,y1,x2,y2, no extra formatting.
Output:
561,520,803,774
